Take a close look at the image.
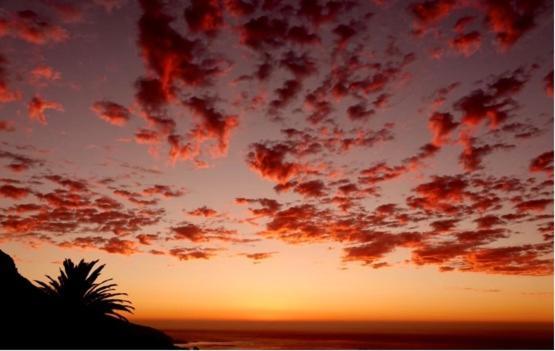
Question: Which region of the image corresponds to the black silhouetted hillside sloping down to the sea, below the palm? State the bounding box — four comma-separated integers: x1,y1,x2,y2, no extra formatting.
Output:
0,250,176,349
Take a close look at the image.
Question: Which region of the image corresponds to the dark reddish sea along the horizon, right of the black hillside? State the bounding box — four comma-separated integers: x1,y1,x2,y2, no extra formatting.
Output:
143,321,554,350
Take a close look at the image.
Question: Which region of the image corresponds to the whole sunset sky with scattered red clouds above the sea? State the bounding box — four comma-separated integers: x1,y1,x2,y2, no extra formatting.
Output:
0,0,553,322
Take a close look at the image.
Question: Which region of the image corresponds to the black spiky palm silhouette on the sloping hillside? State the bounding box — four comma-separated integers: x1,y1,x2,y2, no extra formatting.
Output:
36,259,134,320
